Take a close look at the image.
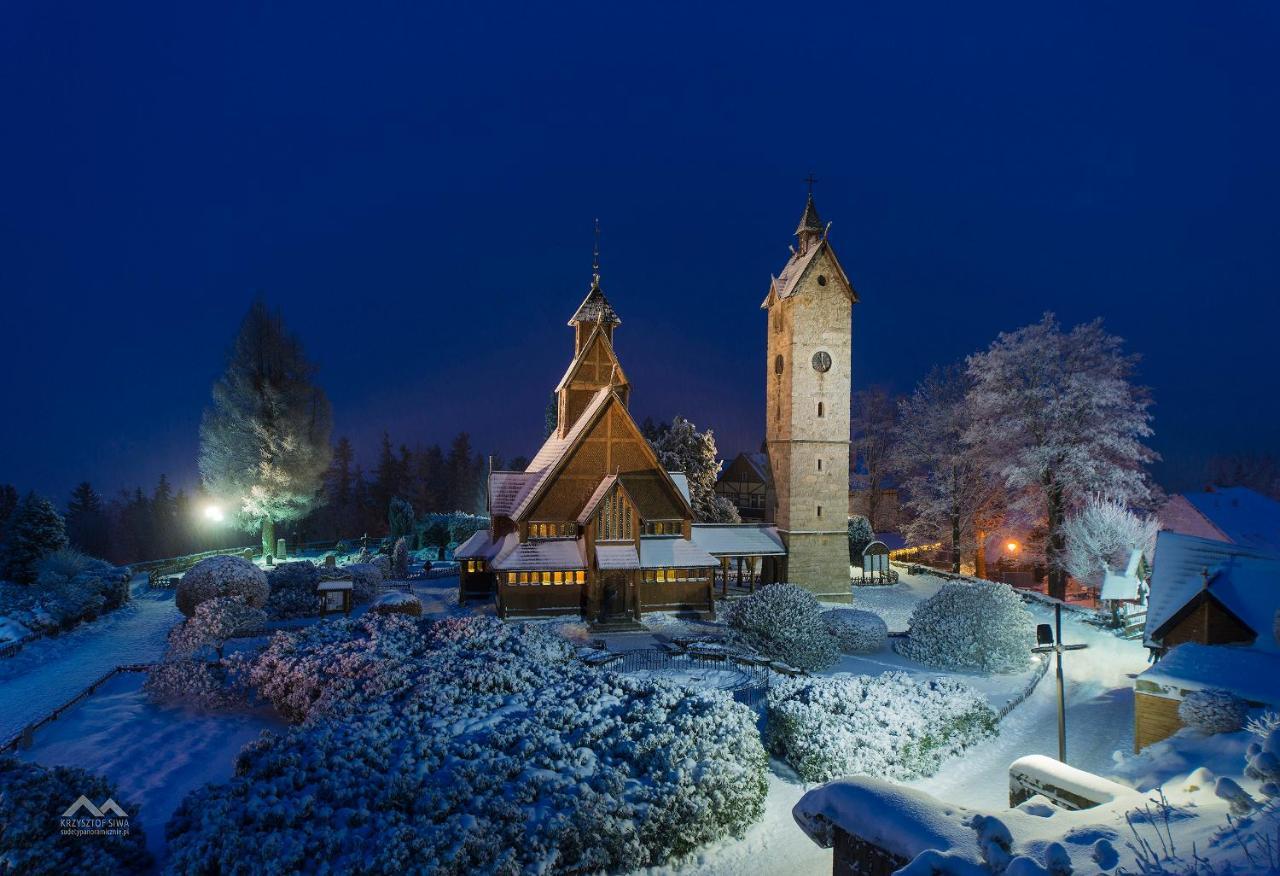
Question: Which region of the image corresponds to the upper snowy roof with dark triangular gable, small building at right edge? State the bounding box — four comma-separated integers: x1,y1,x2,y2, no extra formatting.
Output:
1146,530,1280,651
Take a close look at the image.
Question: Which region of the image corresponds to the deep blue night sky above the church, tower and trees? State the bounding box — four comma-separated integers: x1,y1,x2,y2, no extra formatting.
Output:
0,0,1280,499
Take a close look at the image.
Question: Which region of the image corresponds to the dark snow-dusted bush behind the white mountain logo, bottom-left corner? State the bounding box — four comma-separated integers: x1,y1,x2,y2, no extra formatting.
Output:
0,757,151,875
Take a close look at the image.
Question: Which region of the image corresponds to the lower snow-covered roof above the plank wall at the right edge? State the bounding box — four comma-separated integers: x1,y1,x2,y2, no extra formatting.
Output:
1138,637,1280,706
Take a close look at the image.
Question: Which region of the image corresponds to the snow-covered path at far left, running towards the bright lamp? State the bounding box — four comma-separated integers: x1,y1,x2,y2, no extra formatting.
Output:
0,578,182,739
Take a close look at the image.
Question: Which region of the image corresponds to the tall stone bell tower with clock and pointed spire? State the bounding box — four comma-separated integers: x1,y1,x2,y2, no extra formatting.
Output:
760,190,858,602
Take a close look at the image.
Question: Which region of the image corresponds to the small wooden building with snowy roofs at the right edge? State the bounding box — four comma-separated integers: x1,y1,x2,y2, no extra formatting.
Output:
1134,530,1280,750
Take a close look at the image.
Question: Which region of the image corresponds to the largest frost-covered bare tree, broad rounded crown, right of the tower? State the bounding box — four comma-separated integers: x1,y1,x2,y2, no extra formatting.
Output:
965,314,1156,598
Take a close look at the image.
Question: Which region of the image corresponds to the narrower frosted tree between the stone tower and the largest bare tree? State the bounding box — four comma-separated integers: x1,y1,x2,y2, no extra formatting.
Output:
895,365,1002,572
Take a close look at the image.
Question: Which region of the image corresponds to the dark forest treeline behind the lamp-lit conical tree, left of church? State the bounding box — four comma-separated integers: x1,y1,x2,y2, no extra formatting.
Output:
0,433,509,565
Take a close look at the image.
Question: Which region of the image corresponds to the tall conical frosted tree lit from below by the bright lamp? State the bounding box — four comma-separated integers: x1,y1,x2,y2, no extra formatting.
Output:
200,300,333,556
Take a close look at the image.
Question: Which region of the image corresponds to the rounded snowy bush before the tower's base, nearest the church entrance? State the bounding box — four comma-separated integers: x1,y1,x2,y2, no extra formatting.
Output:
724,584,840,672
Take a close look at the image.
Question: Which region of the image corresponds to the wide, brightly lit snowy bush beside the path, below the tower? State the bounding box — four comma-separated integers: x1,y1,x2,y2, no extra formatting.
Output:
768,672,996,781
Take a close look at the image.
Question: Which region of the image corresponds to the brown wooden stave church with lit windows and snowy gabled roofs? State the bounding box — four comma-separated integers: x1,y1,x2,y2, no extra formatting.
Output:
454,263,786,622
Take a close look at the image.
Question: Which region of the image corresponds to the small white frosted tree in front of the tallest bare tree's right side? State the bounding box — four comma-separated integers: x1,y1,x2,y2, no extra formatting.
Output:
1062,494,1160,587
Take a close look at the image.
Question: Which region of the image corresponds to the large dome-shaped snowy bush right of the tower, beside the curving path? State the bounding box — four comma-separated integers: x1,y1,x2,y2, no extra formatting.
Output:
897,580,1036,672
